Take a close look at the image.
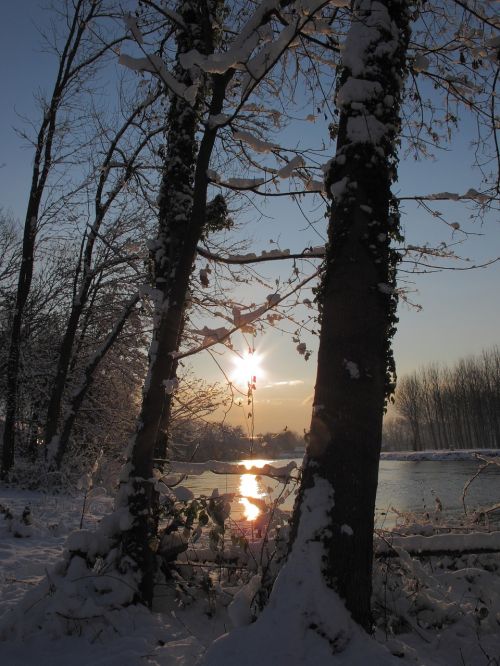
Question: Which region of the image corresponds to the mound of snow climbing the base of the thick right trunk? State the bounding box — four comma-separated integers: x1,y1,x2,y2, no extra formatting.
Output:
200,477,400,666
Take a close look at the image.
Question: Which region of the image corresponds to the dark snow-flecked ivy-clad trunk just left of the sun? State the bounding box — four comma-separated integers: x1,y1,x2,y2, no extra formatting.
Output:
119,0,225,603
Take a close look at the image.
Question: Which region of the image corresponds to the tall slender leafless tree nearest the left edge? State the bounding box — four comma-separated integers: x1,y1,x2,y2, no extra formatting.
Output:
2,0,125,476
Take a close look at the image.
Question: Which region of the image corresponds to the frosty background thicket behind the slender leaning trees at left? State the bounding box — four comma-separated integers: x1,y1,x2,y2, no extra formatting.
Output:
0,205,149,480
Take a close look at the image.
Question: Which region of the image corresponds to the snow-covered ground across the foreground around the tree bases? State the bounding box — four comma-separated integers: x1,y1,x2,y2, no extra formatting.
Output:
0,478,500,666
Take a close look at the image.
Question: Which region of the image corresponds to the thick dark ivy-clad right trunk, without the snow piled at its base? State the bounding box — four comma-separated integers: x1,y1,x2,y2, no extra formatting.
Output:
294,0,410,630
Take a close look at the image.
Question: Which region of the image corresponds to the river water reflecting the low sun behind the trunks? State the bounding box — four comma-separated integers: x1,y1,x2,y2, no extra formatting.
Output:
184,459,500,528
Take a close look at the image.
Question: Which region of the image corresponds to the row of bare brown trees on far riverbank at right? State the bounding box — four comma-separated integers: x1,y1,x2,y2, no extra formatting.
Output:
384,347,500,451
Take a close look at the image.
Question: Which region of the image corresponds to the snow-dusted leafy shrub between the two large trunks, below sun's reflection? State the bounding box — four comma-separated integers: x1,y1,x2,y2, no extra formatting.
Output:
156,466,293,622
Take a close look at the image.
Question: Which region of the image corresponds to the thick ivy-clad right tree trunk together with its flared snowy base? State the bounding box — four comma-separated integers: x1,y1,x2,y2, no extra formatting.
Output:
202,0,410,666
